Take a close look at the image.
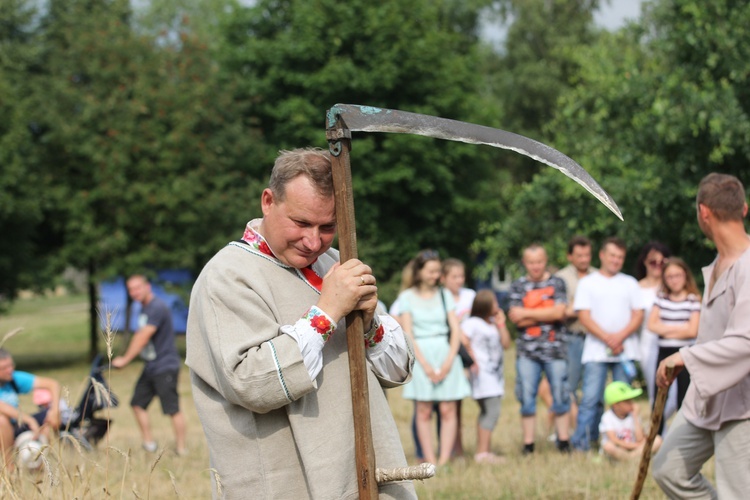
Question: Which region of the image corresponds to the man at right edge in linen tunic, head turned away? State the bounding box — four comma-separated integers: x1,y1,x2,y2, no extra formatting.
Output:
653,173,750,499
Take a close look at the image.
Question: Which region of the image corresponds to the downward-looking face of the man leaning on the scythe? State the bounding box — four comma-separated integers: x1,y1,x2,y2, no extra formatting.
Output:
260,176,336,269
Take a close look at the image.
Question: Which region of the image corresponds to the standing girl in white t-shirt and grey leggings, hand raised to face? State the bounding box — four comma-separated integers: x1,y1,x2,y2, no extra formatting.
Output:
461,290,510,463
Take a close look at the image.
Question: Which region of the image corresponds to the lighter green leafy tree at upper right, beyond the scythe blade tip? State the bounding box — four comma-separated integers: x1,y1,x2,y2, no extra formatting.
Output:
479,0,750,274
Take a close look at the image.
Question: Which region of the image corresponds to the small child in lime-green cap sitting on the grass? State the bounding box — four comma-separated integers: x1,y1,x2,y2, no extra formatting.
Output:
599,382,661,460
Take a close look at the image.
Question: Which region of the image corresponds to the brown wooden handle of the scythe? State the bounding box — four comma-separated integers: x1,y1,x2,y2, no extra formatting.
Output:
329,127,378,500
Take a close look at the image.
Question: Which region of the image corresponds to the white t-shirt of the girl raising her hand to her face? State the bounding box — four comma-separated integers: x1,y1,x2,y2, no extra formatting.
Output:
461,316,505,399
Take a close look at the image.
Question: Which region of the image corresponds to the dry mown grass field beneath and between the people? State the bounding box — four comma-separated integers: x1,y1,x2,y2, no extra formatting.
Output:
0,297,713,499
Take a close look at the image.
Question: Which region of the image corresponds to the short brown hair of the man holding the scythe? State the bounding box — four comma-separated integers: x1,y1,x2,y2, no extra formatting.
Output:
268,148,333,201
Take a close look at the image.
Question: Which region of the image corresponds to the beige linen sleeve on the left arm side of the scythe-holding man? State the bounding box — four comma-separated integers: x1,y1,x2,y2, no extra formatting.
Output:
186,268,316,413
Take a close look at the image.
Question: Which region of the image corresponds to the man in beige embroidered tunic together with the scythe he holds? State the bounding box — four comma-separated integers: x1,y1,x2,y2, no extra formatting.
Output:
186,104,622,498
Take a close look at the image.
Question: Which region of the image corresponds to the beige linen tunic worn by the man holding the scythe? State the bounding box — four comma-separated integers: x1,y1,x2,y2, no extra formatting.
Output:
186,245,416,499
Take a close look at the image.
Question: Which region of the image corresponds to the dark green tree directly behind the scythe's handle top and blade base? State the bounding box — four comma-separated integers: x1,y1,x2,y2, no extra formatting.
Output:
221,0,502,296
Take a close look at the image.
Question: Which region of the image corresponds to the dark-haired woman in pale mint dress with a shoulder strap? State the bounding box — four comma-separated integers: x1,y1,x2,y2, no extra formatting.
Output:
398,250,471,465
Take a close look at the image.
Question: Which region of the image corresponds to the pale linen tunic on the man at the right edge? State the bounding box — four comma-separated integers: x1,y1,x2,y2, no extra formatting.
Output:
680,249,750,431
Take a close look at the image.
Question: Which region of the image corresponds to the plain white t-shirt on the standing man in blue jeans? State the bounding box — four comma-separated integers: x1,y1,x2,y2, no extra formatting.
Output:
573,272,644,363
